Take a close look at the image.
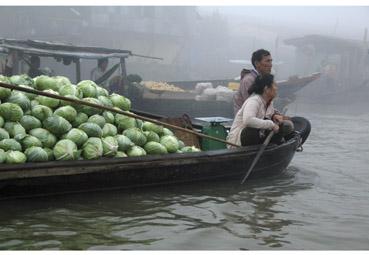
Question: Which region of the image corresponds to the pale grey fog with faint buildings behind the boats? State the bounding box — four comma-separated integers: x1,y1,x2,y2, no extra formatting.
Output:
0,6,369,107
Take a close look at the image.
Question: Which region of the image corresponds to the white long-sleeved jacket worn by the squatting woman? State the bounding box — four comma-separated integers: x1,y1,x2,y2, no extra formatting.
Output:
227,94,275,148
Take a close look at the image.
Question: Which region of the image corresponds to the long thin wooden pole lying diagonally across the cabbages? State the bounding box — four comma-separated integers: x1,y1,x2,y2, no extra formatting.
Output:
0,82,241,147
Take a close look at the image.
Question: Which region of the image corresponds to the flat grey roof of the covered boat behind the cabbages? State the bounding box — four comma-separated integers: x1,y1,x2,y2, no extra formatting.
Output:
0,38,161,59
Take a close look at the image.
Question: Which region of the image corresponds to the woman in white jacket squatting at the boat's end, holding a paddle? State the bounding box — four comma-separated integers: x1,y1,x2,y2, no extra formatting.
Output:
227,74,294,148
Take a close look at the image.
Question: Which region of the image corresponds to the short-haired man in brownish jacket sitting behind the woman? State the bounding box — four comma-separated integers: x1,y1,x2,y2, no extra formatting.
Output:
233,49,273,115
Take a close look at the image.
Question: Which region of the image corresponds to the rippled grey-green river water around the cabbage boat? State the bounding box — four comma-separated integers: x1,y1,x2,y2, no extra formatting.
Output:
0,103,369,250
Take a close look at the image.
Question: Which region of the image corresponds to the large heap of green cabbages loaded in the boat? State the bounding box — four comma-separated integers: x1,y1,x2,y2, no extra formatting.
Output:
0,75,199,164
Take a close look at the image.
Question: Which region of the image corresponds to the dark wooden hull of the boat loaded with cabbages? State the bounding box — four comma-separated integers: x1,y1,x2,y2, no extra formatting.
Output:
0,118,310,200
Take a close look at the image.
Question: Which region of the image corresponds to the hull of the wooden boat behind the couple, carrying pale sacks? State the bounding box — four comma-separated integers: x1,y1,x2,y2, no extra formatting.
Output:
128,73,320,119
